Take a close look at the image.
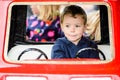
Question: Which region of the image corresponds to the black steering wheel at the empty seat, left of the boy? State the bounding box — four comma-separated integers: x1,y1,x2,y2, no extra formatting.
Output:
18,48,48,60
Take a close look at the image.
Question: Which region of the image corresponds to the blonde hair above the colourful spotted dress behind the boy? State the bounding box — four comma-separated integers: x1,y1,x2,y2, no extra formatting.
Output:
37,5,59,21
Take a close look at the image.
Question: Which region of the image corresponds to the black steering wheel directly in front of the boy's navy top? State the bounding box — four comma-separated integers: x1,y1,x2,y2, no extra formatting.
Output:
75,47,106,60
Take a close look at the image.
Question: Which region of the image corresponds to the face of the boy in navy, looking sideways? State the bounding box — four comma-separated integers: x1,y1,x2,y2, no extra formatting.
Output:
61,14,85,45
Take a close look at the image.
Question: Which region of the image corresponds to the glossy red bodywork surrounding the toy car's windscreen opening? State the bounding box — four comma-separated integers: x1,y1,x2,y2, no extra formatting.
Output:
0,0,120,80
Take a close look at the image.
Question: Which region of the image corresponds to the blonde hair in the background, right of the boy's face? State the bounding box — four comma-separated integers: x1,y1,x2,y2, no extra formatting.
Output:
85,11,101,42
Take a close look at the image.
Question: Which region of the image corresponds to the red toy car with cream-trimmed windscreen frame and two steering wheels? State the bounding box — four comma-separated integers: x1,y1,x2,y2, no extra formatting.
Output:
0,0,120,80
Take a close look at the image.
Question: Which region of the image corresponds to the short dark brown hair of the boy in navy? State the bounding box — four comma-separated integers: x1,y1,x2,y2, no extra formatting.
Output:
61,5,87,24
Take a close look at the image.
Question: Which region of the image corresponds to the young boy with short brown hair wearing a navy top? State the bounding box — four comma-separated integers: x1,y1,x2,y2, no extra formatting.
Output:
51,5,99,59
